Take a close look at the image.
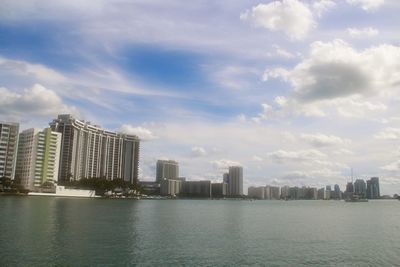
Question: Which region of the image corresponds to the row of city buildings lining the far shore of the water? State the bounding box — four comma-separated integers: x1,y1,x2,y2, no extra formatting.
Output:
0,114,396,200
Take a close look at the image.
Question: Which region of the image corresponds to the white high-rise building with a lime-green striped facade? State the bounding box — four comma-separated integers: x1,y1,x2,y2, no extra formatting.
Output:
15,128,61,191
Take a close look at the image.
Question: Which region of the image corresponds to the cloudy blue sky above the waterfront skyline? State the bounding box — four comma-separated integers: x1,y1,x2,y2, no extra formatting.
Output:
0,0,400,194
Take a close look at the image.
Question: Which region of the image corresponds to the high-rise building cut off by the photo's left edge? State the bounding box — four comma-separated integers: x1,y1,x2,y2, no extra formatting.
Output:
0,122,19,182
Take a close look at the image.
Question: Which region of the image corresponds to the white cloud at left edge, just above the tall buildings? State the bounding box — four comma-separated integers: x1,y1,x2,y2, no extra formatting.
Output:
0,84,79,119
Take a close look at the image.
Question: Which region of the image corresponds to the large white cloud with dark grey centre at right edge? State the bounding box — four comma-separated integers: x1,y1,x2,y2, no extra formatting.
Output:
264,40,400,102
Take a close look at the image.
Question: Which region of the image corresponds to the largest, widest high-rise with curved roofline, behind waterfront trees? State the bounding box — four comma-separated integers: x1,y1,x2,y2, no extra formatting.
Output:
50,114,140,183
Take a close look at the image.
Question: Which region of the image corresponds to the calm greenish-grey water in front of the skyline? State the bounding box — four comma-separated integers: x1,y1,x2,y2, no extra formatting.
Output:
0,197,400,266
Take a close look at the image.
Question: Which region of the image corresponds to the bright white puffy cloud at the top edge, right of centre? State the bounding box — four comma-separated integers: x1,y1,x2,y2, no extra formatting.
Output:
240,0,316,40
